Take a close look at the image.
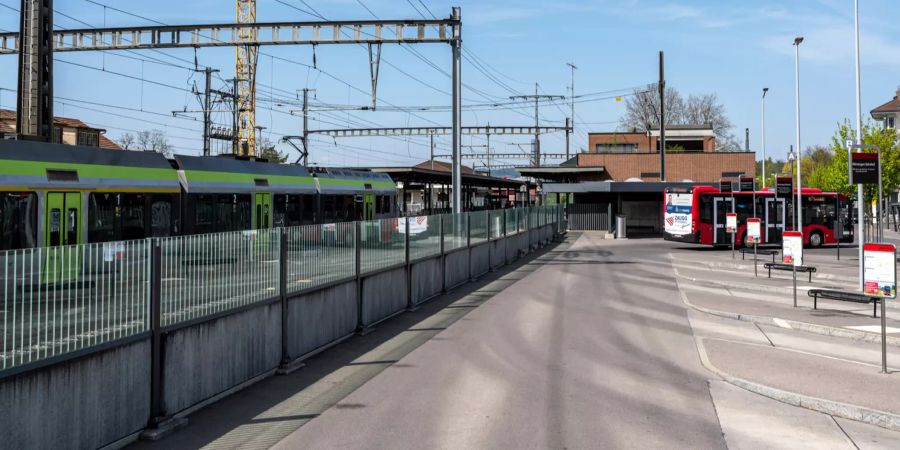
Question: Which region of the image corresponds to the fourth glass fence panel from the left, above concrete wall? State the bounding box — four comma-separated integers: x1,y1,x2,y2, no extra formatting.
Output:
359,219,406,273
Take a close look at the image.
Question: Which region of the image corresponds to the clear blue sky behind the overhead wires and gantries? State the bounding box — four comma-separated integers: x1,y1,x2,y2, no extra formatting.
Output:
0,0,900,165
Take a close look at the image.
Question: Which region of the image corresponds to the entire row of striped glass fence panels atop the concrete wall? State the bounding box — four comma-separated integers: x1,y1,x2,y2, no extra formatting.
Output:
0,206,561,373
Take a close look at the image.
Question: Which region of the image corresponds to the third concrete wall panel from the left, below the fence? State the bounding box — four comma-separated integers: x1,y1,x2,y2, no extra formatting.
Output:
287,280,359,359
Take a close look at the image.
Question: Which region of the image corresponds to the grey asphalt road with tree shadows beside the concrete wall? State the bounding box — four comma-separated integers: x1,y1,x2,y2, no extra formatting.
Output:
278,235,725,449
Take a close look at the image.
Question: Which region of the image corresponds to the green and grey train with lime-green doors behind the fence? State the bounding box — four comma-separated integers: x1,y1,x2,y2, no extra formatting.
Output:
0,141,398,250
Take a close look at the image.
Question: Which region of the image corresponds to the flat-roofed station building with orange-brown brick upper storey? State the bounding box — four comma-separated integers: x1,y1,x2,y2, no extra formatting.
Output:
517,126,756,235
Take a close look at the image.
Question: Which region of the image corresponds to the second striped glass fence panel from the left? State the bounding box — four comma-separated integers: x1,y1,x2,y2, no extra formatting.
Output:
160,230,280,326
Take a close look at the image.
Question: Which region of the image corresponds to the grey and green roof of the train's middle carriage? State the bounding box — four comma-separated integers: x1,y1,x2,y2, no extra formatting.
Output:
174,155,316,194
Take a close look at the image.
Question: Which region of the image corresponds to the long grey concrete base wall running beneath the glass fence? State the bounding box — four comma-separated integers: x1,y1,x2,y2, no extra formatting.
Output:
0,222,553,448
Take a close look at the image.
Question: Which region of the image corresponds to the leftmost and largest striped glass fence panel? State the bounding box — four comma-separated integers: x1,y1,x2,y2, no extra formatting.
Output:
0,241,150,370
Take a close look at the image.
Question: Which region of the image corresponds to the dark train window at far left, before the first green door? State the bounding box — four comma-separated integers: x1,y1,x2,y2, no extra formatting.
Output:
0,192,37,250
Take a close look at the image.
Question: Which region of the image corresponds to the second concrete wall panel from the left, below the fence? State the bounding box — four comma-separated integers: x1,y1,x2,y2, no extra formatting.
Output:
163,302,281,414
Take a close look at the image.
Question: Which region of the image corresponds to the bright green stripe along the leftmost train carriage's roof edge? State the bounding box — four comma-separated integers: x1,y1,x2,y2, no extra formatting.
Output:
0,159,178,181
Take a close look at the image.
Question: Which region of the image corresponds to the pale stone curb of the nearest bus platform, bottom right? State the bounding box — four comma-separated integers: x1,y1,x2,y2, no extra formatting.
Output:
694,336,900,431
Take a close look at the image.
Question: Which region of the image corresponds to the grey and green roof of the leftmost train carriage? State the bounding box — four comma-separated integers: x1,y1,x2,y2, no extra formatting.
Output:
0,140,179,192
